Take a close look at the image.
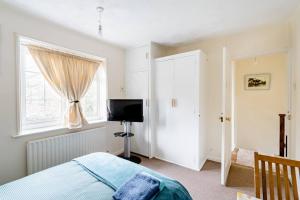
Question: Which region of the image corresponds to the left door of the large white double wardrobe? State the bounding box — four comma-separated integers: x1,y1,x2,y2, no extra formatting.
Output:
153,60,177,161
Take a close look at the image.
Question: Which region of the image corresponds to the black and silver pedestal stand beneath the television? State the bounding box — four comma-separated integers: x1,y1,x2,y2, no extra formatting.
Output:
114,121,141,164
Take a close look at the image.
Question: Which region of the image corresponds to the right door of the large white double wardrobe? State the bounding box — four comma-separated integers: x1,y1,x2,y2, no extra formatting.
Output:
172,56,199,168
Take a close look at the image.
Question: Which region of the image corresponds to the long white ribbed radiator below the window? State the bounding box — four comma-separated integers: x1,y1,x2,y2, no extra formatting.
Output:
27,127,106,174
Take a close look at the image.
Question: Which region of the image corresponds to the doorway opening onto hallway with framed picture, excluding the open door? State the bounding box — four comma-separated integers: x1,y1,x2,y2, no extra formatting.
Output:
231,52,291,167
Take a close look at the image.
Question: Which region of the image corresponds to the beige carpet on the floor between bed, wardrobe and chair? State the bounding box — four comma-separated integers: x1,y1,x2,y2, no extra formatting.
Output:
141,158,253,200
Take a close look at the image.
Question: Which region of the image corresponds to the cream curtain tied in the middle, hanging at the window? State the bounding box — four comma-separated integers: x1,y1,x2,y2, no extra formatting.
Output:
27,45,102,129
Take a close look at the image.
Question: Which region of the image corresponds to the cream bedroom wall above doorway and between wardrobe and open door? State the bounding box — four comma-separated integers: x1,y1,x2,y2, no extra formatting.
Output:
168,23,289,160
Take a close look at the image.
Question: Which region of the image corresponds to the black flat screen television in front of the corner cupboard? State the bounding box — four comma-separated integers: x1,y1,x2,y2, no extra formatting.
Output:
107,99,144,122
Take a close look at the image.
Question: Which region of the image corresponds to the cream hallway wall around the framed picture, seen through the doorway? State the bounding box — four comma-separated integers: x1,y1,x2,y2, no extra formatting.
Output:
235,53,288,155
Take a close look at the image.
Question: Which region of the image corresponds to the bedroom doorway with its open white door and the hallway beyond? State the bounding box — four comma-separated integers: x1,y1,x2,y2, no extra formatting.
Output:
220,47,293,185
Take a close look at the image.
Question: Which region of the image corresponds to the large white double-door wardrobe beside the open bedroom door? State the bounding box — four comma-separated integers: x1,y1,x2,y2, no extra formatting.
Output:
153,50,208,170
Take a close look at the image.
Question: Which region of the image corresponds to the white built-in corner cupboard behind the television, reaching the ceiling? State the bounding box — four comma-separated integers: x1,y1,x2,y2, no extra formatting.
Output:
125,42,163,158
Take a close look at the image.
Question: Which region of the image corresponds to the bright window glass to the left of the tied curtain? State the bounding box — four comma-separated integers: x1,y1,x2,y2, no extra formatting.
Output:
21,46,63,130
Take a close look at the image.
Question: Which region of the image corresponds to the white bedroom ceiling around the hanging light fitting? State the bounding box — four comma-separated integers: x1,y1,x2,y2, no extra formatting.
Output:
0,0,300,47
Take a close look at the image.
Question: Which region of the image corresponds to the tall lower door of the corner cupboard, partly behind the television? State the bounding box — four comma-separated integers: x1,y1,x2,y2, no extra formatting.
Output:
126,71,150,157
